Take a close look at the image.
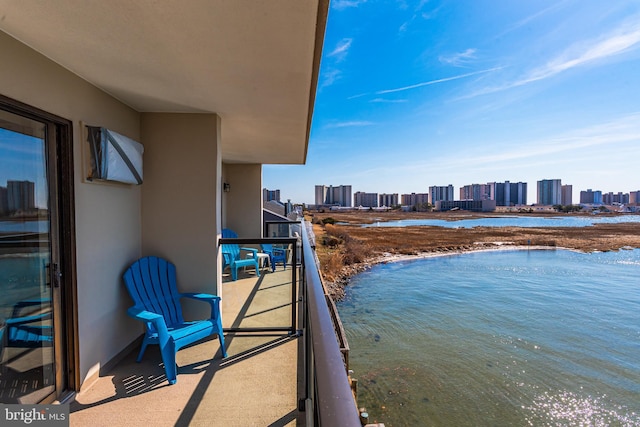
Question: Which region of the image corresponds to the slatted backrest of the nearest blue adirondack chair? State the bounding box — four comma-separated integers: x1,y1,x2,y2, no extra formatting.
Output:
124,257,184,327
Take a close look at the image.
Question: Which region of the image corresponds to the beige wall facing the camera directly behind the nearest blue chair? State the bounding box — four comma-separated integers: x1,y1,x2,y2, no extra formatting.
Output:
142,113,221,318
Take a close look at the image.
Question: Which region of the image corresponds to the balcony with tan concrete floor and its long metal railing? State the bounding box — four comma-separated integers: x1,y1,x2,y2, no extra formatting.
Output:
70,223,361,426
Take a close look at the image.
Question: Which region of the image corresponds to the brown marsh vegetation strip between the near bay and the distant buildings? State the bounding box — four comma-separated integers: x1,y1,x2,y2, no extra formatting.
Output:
308,212,640,299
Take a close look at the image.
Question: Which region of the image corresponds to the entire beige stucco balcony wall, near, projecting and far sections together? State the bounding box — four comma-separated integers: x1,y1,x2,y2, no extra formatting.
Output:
0,28,262,392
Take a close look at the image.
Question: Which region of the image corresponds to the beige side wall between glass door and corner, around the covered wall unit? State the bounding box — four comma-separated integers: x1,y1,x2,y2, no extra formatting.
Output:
0,32,142,388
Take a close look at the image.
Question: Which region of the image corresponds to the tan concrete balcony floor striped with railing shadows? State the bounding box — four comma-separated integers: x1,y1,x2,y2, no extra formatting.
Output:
70,267,302,427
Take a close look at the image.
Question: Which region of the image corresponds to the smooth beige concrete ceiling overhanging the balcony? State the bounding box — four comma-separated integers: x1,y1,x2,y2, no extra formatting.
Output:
0,0,329,164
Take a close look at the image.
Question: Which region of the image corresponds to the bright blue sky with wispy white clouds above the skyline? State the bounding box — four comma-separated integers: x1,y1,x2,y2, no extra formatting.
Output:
263,0,640,204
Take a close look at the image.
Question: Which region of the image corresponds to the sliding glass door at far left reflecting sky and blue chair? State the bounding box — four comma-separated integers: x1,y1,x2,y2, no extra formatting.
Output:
0,102,68,403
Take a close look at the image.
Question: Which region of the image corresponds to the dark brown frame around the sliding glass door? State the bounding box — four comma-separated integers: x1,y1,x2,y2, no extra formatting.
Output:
0,94,80,403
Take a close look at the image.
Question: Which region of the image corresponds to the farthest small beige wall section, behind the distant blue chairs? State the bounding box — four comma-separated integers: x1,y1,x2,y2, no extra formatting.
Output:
222,163,262,238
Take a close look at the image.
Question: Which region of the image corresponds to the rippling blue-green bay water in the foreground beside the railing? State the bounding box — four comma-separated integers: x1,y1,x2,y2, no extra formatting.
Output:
338,250,640,427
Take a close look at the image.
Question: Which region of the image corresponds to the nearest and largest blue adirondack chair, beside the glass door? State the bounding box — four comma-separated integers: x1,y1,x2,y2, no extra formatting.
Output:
124,257,227,384
